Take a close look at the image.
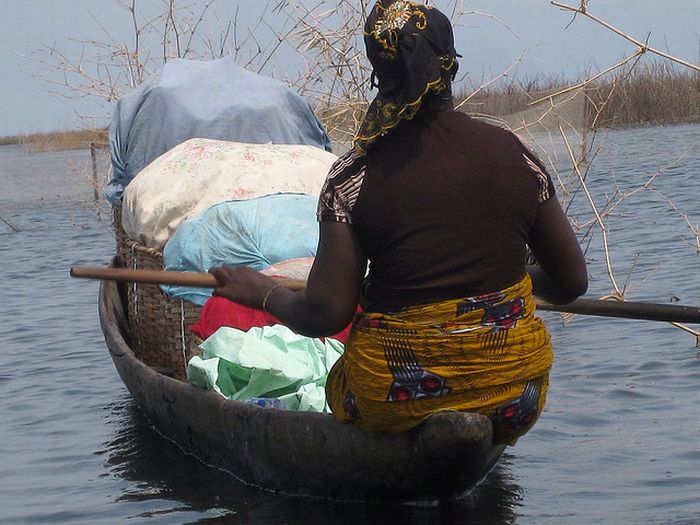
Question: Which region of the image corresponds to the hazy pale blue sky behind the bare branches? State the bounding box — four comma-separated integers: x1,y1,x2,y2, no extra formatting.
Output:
0,0,700,136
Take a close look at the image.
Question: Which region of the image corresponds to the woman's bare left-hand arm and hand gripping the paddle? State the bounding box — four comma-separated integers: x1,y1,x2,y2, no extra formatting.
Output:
210,222,367,337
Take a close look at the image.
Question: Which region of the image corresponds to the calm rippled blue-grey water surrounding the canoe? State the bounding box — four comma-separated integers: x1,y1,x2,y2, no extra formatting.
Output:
0,126,700,525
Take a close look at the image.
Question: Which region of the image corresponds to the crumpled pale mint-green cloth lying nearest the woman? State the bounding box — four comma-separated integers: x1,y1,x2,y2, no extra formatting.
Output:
187,325,343,412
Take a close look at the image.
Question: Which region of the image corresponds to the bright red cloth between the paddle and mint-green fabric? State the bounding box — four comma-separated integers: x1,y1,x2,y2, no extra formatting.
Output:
190,297,360,343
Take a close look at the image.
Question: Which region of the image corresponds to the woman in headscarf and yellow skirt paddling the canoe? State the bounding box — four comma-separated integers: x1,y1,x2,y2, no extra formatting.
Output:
211,0,588,444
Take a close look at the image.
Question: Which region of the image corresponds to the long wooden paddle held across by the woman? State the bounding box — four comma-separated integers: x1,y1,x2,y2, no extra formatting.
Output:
70,266,700,323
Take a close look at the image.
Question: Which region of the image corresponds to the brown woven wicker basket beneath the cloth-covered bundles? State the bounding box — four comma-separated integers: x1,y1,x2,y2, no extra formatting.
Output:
114,206,202,380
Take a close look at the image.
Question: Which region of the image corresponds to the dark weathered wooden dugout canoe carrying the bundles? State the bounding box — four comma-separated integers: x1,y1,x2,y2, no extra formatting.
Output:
99,274,504,502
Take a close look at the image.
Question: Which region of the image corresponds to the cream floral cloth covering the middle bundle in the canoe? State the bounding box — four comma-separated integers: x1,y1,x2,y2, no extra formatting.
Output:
122,139,336,250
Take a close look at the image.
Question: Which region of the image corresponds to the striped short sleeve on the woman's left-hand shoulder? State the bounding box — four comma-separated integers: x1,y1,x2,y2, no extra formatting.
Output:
316,151,365,224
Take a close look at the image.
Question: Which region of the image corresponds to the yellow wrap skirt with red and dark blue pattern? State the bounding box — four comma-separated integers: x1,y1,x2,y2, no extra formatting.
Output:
326,275,553,444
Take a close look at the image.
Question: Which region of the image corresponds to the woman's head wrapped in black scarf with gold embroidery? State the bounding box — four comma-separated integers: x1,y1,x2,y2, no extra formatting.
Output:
355,0,459,152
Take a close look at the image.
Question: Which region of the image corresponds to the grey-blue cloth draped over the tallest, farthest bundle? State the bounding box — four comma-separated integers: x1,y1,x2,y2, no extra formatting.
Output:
105,58,331,205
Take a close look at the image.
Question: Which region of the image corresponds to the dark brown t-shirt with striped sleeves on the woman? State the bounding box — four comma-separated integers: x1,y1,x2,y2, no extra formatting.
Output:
318,111,554,309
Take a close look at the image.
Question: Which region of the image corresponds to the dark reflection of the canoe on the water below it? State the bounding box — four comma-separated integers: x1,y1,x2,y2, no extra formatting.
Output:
104,398,523,525
